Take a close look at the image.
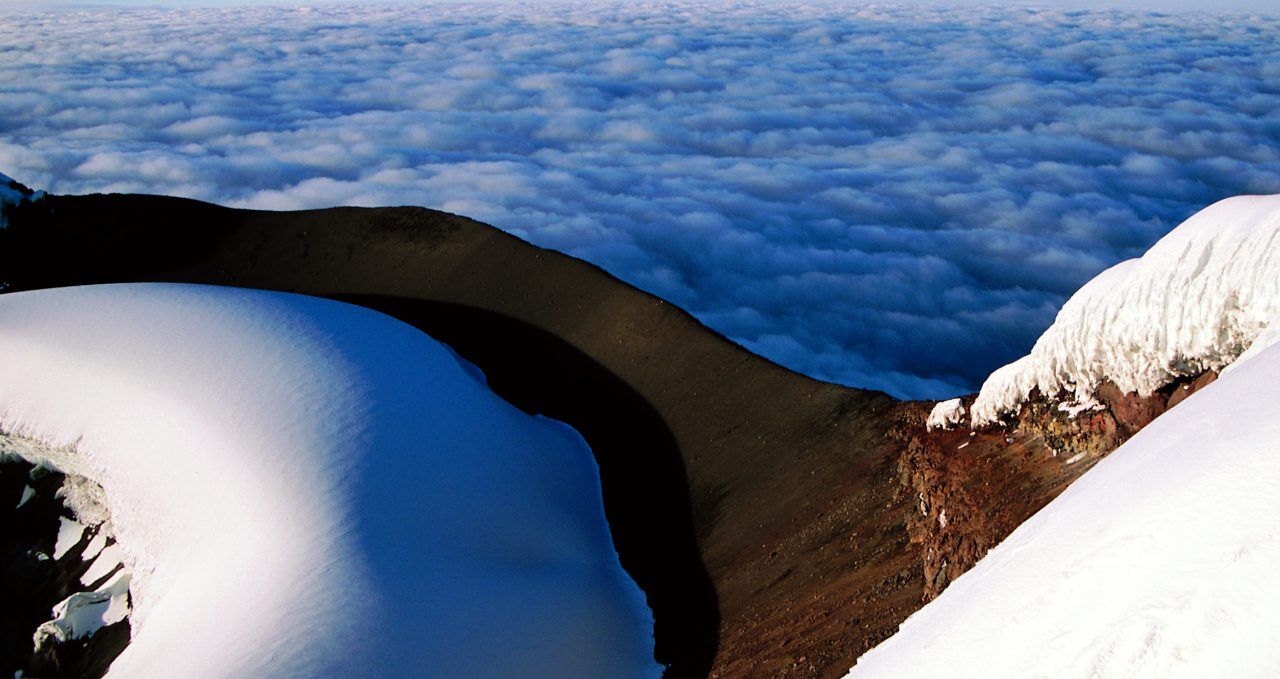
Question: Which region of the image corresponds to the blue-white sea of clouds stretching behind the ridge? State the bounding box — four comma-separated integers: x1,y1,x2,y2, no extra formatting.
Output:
0,3,1280,397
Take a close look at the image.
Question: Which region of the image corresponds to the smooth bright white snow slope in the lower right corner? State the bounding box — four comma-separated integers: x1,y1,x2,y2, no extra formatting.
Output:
850,326,1280,679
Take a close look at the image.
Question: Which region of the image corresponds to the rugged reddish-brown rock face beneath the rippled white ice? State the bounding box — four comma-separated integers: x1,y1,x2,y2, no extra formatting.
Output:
895,372,1217,601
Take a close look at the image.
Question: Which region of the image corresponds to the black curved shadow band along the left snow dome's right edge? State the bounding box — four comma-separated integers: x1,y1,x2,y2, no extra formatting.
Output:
334,295,719,676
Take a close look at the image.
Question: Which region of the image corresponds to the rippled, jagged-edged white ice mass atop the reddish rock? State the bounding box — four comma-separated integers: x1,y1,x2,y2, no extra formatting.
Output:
972,196,1280,427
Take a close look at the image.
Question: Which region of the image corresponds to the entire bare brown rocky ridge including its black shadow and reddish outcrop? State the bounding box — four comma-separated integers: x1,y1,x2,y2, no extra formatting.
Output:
0,196,1208,676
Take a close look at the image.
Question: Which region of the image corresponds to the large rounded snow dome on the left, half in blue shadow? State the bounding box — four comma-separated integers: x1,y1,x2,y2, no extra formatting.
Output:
0,284,659,676
